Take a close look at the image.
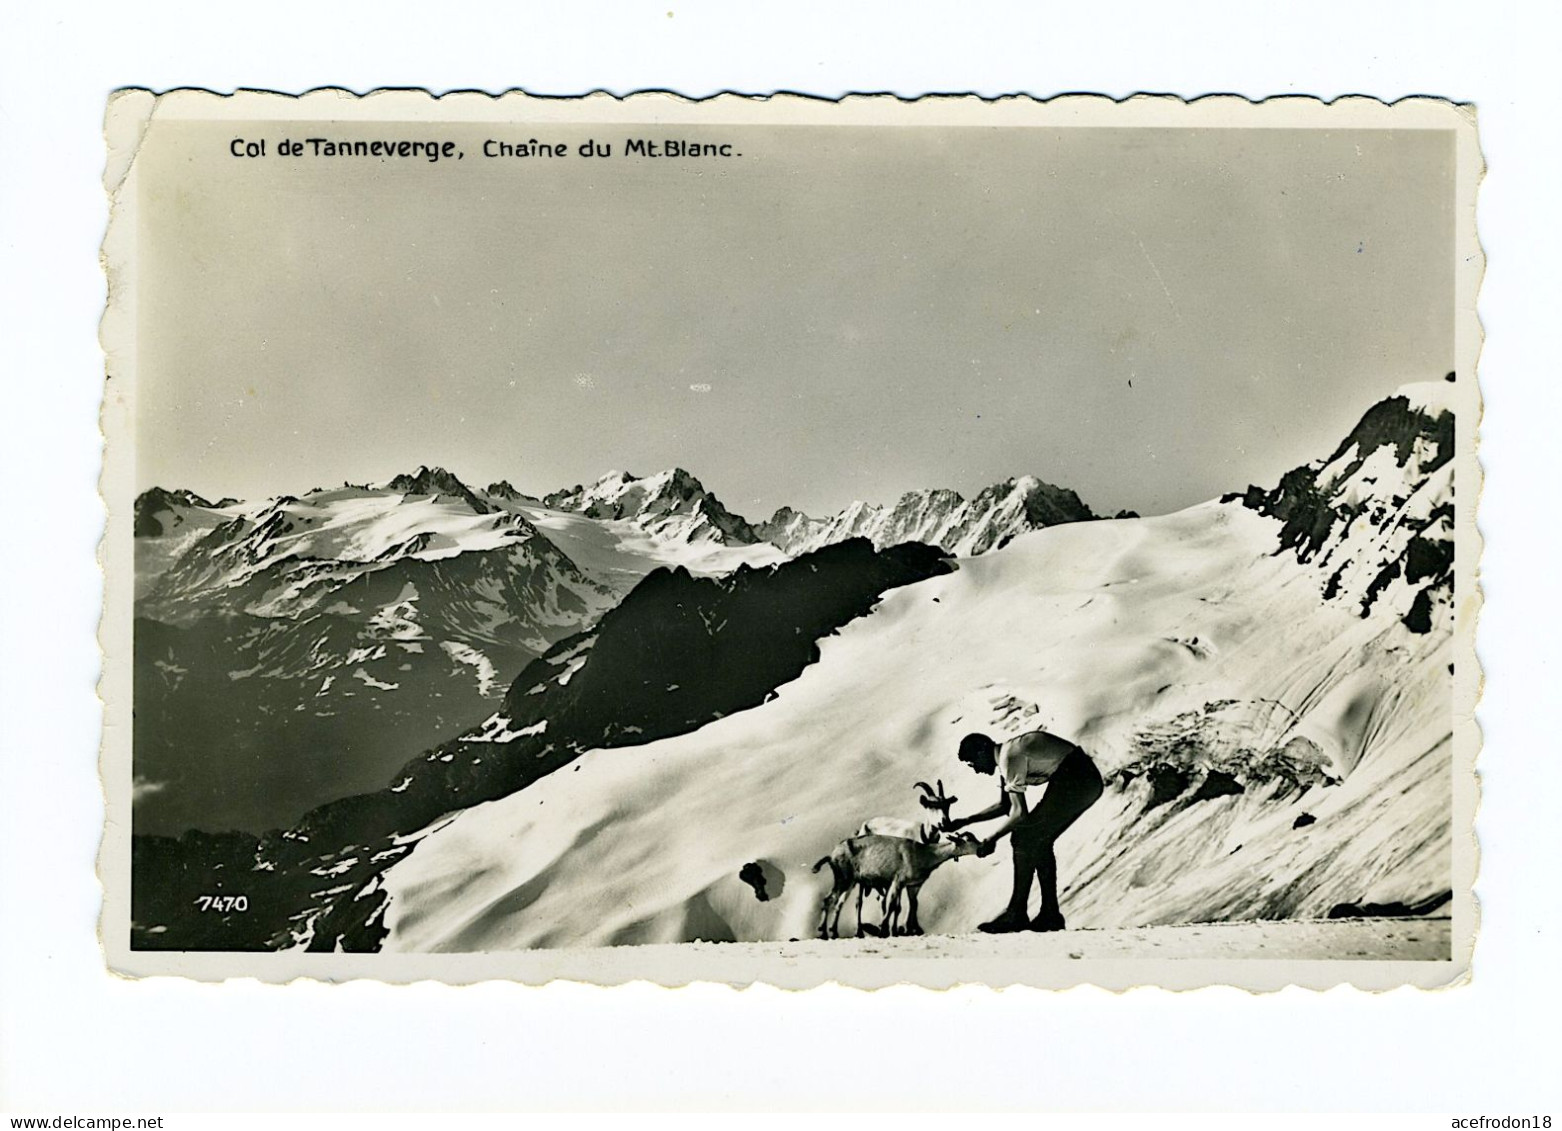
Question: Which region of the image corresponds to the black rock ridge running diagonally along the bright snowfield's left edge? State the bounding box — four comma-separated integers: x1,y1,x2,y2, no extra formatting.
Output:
134,539,951,950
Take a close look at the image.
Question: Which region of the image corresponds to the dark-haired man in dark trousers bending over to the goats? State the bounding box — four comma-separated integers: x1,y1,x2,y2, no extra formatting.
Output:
945,731,1103,934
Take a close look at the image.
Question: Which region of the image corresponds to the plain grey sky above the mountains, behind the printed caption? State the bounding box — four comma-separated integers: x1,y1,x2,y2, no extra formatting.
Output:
137,123,1454,519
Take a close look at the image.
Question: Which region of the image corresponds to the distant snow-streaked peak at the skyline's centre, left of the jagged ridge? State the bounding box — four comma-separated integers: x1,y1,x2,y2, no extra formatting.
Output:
542,467,761,545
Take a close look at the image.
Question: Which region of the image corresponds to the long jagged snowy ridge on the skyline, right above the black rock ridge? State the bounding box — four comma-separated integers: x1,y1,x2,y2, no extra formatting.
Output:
754,475,1095,558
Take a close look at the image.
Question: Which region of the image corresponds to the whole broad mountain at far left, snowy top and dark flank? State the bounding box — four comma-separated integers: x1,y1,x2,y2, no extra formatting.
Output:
134,469,615,831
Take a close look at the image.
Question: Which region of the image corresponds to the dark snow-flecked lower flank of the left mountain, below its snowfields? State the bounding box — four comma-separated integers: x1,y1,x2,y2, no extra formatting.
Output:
134,514,590,833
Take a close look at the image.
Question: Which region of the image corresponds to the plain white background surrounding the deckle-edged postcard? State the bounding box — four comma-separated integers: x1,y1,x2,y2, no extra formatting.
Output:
0,0,1562,1126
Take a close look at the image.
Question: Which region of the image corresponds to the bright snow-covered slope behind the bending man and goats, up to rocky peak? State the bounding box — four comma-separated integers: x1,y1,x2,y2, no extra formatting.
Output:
376,385,1453,950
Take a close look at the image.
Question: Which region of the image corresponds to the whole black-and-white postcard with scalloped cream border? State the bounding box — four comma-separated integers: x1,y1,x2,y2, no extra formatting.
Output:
100,91,1482,989
